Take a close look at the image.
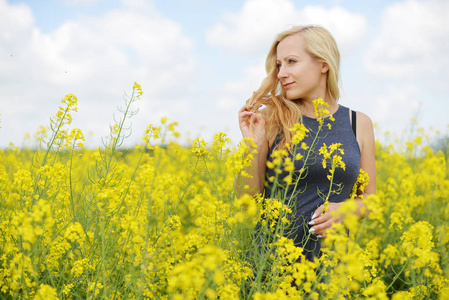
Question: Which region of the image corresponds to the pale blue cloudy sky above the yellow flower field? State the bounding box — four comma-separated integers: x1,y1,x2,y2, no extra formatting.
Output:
0,0,449,148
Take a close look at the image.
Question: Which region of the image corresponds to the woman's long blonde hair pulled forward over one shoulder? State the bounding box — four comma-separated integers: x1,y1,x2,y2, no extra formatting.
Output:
247,25,340,149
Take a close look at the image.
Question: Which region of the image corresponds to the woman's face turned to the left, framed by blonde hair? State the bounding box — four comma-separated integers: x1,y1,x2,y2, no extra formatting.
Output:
277,34,329,101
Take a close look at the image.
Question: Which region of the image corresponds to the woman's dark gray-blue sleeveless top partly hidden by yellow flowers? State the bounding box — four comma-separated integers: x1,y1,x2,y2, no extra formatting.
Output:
265,105,360,260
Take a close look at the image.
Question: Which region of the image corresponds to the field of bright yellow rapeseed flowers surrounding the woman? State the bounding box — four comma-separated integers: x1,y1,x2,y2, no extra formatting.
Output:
0,90,449,300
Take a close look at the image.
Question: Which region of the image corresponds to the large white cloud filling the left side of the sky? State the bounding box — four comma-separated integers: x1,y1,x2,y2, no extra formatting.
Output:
0,0,196,146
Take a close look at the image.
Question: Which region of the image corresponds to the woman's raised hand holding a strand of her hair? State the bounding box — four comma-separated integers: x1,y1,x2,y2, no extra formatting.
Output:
239,105,265,146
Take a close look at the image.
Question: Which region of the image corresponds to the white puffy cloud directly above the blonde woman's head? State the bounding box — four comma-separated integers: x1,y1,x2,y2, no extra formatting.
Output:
207,0,366,55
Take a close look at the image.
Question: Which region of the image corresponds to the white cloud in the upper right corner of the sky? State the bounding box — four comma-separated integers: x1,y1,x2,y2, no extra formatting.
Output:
364,0,449,82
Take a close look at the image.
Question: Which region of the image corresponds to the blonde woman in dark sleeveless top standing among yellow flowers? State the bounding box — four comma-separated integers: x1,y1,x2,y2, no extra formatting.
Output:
236,26,376,260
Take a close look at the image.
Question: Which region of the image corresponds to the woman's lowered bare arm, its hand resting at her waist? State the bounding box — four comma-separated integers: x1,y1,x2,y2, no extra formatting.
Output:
310,112,376,235
